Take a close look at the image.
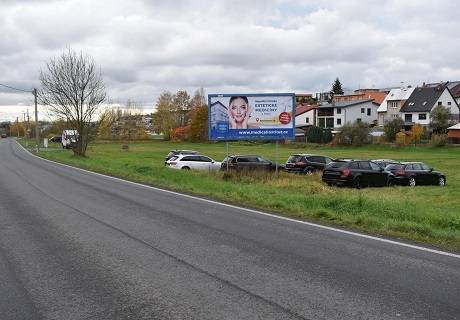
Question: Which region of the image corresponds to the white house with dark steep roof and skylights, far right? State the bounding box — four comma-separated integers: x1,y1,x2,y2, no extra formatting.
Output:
400,85,460,127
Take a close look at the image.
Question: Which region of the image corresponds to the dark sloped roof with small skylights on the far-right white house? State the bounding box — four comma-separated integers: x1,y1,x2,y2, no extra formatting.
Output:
401,86,446,112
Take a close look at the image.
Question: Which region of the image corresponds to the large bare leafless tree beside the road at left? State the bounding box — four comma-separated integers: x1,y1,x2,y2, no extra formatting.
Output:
38,49,106,156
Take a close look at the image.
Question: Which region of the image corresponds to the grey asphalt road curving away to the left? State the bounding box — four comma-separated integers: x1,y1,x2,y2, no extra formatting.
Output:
0,139,460,320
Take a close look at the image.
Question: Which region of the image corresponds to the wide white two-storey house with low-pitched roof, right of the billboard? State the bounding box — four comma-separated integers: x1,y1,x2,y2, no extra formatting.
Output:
316,99,378,129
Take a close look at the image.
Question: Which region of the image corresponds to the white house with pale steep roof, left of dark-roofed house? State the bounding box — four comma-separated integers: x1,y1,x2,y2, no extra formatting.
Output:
377,86,414,127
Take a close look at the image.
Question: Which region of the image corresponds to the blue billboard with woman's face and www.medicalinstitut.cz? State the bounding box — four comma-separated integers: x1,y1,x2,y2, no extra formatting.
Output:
208,93,295,140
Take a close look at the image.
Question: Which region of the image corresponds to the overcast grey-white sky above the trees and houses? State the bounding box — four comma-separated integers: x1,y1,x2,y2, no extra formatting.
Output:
0,0,460,119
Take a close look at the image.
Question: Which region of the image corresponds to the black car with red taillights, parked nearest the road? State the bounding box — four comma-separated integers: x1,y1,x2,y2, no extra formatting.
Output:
322,160,392,189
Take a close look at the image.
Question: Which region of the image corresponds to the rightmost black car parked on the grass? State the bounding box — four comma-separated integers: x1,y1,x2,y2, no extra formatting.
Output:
385,162,446,187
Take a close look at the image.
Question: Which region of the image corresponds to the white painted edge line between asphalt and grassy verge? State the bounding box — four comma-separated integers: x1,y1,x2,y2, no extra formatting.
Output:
16,141,460,259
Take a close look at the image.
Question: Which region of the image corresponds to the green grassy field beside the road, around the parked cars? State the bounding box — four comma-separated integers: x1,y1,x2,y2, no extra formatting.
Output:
20,141,460,251
